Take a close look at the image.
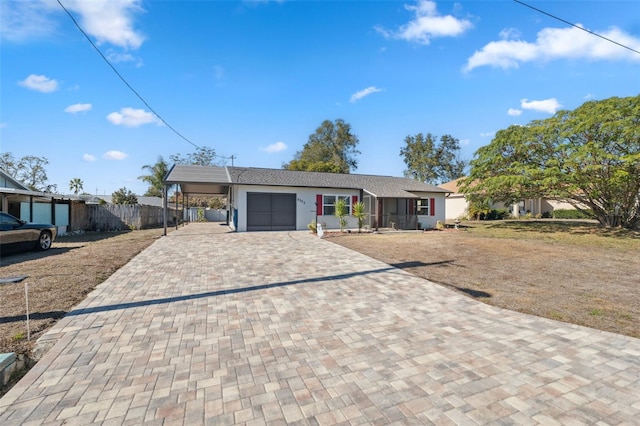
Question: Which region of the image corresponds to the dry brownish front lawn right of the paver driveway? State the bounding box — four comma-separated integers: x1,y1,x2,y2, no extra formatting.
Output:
327,221,640,338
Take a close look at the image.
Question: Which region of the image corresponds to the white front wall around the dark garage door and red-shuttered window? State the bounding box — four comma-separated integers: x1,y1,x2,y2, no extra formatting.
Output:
230,185,360,232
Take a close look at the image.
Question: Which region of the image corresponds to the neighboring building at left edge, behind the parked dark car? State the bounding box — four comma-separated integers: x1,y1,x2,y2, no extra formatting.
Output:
0,169,80,235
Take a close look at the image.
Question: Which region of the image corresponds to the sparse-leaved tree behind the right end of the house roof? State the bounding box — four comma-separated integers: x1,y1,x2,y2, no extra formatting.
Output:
400,133,467,184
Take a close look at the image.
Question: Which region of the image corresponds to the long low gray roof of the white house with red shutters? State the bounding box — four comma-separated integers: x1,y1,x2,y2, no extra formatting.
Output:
165,165,450,198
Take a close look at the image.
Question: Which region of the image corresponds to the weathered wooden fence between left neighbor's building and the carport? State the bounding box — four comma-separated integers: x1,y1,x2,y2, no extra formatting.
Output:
71,204,175,231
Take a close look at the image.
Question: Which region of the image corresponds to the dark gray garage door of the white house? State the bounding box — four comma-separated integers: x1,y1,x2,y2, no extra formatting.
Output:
247,192,296,231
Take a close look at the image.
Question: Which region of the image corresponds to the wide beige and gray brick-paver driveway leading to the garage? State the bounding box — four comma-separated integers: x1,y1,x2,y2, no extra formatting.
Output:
0,223,640,426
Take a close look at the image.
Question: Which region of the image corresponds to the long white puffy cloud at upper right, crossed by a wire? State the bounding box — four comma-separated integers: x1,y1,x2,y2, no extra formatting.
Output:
464,27,640,71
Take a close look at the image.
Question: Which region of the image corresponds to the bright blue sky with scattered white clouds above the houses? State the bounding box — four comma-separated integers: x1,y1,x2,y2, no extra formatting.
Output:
0,0,640,194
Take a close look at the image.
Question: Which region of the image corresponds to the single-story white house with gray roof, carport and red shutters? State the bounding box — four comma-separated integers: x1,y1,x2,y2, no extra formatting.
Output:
165,165,448,231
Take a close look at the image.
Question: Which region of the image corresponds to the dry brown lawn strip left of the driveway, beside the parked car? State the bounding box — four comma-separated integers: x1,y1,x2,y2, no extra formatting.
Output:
0,229,163,354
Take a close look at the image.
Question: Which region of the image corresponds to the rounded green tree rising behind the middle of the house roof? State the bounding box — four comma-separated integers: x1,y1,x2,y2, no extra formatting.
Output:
282,118,360,173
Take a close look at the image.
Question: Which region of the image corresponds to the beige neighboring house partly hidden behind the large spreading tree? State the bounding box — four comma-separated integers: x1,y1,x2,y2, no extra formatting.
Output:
440,178,575,220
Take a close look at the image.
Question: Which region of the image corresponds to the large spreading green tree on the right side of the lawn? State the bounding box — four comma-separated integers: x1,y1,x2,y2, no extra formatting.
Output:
461,96,640,228
